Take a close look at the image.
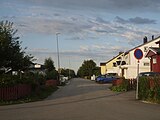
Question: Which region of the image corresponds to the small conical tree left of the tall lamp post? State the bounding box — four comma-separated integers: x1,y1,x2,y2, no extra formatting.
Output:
44,58,58,79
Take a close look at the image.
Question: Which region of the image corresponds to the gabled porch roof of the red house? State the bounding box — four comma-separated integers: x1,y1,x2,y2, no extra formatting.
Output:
145,47,160,57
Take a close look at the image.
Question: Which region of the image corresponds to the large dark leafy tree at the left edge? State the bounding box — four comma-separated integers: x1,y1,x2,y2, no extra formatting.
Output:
0,21,33,70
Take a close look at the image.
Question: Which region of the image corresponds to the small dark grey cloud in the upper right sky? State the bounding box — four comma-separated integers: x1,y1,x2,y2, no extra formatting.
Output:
115,16,156,24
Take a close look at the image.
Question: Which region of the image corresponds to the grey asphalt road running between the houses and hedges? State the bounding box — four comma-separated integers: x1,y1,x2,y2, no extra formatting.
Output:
0,78,160,120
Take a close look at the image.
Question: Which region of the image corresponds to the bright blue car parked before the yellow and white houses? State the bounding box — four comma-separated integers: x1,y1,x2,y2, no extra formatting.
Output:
96,73,119,83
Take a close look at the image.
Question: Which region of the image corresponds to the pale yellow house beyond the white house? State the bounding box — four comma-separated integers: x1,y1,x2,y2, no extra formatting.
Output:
100,52,123,75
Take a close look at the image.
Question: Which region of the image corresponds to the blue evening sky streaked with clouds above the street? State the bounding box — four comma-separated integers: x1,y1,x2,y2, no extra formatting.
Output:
0,0,160,71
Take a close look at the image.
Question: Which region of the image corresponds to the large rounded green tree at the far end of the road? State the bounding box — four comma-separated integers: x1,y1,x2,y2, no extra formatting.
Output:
77,60,98,78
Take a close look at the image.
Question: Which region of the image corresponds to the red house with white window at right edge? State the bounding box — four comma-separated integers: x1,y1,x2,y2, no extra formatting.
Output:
145,41,160,72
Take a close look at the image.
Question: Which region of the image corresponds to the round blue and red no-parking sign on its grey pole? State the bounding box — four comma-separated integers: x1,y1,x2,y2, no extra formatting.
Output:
134,48,143,99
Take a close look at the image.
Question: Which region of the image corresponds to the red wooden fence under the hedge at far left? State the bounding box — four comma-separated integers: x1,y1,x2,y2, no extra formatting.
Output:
0,84,31,100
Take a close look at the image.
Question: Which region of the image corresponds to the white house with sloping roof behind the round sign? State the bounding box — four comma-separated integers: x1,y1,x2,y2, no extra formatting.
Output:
100,36,160,79
